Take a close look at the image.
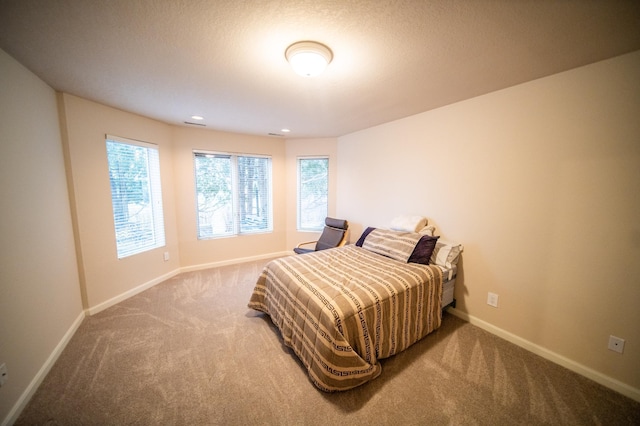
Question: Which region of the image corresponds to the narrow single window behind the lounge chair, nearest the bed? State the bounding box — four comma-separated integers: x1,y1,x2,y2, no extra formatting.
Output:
298,157,329,231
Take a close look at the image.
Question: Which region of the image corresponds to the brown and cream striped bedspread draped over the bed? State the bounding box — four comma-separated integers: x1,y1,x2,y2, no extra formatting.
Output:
249,245,442,392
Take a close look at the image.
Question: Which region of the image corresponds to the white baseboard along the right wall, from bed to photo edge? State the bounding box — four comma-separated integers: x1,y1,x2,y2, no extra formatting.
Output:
447,308,640,402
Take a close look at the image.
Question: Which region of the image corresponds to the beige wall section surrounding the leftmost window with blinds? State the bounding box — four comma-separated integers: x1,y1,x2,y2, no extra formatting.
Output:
60,94,180,311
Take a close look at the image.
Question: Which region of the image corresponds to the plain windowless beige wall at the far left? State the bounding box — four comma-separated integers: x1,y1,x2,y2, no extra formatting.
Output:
0,50,84,424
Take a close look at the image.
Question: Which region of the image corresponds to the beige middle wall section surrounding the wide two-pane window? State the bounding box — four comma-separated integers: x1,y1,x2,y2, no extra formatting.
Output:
172,127,286,268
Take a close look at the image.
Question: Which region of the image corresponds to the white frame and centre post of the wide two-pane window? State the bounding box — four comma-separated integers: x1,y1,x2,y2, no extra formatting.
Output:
193,150,273,240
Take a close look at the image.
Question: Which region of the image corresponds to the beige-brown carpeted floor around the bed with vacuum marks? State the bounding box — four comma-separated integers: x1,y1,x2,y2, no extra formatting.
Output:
16,261,640,425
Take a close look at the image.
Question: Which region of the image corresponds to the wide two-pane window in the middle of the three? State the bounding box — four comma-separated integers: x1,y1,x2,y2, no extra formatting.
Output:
194,152,273,239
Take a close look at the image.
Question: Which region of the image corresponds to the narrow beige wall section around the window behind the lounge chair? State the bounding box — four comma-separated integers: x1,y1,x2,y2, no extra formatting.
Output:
286,138,338,251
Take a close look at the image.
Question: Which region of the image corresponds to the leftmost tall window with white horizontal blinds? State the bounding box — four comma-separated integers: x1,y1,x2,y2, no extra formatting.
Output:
106,135,165,259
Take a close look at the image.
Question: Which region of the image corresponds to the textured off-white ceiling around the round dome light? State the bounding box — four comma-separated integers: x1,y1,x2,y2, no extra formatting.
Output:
0,0,640,138
